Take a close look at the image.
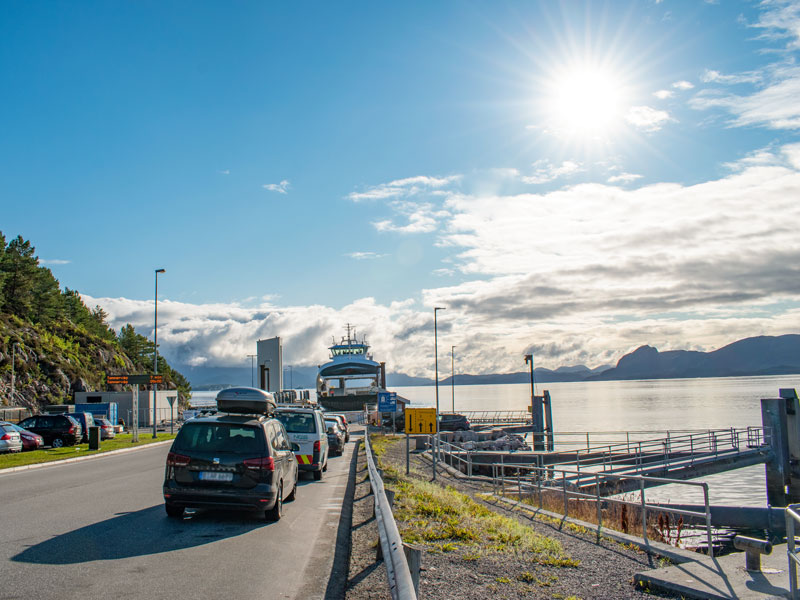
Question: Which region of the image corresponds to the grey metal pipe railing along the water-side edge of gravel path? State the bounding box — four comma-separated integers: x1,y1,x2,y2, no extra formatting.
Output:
428,437,716,556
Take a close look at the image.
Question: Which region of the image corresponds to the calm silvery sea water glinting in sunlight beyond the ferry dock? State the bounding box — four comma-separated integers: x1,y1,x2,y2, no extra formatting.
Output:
194,375,800,506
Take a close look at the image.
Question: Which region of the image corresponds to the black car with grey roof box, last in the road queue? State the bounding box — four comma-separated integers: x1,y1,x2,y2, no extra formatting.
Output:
163,388,299,521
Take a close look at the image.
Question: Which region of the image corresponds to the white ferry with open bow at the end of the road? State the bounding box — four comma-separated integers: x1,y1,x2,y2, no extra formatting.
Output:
317,323,386,411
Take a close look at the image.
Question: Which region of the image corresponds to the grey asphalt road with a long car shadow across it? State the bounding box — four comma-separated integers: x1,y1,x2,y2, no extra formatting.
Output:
0,441,354,600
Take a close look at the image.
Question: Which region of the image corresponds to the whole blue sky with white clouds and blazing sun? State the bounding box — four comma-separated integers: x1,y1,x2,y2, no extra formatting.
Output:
0,0,800,374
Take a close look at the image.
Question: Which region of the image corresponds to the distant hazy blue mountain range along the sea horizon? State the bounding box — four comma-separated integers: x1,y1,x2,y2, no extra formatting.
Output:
179,334,800,390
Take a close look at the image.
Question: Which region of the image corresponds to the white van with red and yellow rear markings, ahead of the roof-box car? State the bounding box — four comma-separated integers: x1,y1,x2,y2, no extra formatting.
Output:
275,405,328,481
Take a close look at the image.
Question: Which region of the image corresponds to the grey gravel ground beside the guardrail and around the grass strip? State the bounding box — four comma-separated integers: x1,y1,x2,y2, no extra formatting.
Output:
346,434,674,600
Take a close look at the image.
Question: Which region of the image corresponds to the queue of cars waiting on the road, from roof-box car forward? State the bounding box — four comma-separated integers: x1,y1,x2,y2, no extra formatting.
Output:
163,387,354,521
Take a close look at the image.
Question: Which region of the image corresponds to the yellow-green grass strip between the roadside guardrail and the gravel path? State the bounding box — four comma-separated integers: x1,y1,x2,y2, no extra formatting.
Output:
370,435,580,567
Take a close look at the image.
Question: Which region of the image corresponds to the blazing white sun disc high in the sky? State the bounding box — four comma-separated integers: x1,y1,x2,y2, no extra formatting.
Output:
544,66,624,138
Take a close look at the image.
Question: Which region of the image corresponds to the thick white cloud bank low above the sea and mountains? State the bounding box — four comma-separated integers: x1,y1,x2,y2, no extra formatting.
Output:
84,144,800,376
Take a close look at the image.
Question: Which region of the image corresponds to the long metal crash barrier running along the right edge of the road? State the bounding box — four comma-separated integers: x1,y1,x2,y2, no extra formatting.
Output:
364,428,417,600
